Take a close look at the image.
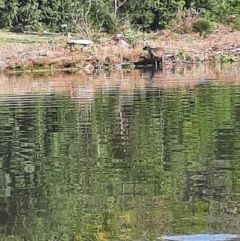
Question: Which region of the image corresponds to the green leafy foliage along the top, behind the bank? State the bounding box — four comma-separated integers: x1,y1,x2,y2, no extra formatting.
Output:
0,0,240,35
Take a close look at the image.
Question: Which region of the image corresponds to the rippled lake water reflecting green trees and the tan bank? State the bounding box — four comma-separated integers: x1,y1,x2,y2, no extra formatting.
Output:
0,65,240,241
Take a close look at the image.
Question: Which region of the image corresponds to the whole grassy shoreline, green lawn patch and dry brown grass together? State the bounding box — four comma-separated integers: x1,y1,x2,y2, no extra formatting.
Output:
0,26,240,74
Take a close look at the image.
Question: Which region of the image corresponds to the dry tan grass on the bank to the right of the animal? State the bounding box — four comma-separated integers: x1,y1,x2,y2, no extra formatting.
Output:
155,26,240,63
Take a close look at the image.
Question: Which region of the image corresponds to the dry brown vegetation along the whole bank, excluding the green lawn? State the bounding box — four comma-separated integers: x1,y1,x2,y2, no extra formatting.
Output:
0,26,240,73
